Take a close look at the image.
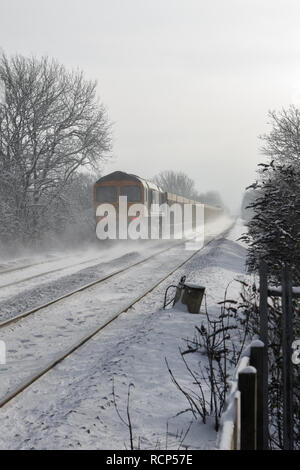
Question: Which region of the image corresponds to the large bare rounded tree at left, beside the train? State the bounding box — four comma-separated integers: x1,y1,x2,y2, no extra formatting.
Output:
0,55,111,242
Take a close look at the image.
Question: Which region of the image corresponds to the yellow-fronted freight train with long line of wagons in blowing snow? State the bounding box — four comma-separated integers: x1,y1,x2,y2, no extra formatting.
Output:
94,171,223,239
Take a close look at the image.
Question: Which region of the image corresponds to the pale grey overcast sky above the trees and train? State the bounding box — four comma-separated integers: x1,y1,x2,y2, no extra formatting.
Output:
0,0,300,208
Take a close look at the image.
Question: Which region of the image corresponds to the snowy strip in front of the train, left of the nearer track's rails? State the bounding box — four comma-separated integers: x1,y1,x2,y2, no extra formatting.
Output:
0,241,178,302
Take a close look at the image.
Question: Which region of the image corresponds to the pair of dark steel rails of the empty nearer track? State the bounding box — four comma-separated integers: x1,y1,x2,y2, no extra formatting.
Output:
0,226,231,408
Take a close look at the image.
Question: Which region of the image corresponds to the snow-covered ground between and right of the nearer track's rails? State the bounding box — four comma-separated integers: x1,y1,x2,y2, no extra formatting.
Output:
0,221,246,449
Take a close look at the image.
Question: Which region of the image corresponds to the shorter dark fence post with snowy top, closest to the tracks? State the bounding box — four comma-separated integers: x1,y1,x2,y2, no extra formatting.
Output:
238,366,257,450
